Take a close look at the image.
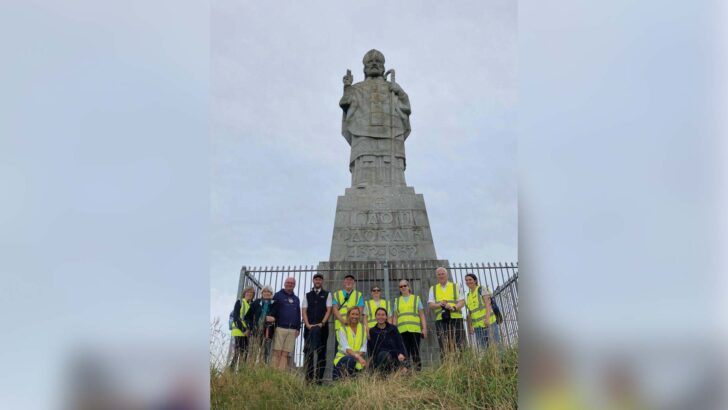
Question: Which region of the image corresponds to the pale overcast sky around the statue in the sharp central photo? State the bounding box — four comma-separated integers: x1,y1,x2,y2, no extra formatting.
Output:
210,1,518,318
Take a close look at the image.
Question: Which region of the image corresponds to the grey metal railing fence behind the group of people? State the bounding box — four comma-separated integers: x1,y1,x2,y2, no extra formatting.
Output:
231,262,518,367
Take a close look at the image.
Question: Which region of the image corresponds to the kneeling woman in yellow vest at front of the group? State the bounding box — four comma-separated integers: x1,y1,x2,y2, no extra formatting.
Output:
333,306,367,380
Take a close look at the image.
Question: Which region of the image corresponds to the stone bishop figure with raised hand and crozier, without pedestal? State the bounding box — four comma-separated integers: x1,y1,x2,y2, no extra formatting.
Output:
339,50,411,188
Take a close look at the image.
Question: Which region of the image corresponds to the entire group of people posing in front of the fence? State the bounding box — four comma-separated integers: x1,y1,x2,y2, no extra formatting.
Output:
230,267,500,384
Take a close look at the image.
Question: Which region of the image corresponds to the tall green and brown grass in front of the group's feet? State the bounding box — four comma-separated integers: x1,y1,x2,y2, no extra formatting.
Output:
210,320,518,410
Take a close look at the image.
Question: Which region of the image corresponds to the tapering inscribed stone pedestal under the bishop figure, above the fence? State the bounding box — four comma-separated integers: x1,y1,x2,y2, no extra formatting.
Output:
329,186,437,262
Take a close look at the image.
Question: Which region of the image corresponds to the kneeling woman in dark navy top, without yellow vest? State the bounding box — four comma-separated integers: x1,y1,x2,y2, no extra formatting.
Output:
367,308,406,373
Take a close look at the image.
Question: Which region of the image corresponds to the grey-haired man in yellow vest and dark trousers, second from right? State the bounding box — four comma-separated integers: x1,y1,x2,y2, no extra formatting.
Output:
427,266,465,359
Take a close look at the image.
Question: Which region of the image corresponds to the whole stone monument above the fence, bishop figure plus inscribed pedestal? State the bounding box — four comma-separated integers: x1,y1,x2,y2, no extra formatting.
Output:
328,50,444,262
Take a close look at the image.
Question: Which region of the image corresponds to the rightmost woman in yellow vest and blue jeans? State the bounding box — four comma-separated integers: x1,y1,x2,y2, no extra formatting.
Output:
465,273,500,350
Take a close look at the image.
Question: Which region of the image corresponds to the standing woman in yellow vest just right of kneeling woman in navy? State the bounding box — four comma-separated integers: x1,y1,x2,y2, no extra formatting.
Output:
392,279,427,370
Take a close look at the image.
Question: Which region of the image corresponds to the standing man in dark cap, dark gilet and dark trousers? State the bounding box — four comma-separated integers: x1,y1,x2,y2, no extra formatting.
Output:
302,272,331,384
